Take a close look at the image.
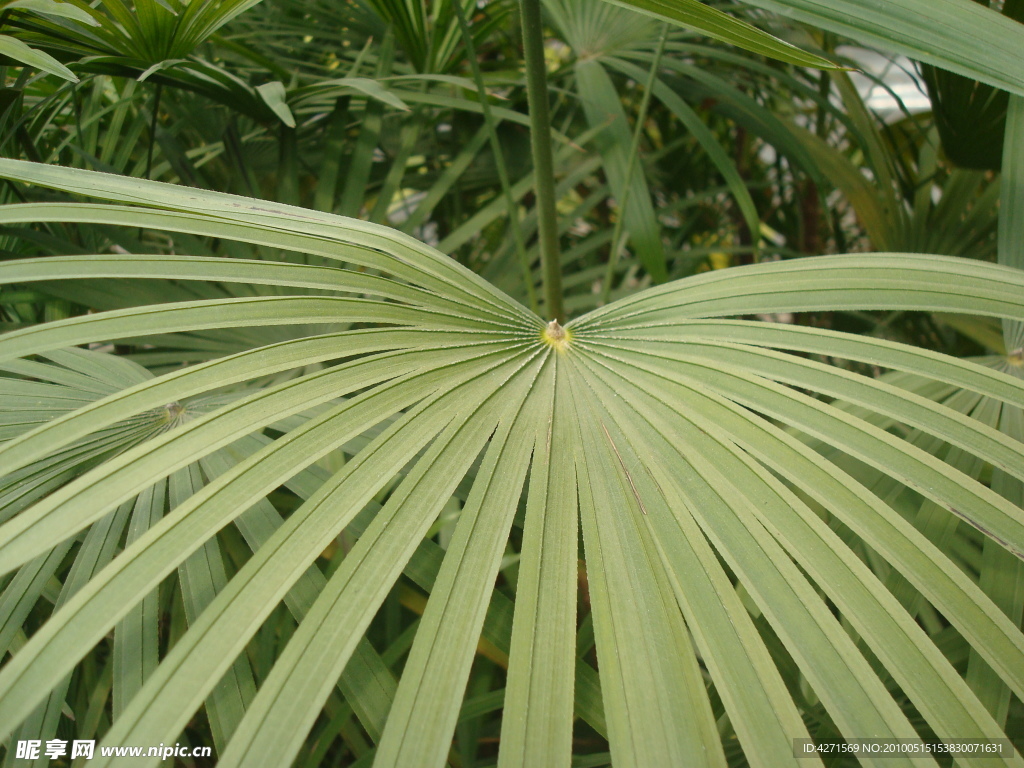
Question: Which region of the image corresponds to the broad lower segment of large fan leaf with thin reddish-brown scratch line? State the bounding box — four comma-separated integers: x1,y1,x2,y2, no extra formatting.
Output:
570,371,725,767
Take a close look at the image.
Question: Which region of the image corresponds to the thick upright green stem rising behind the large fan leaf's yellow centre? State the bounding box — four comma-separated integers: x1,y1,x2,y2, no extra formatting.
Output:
519,0,565,323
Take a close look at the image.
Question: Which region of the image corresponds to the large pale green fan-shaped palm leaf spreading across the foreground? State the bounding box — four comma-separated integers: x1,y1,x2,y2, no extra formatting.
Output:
0,161,1024,767
